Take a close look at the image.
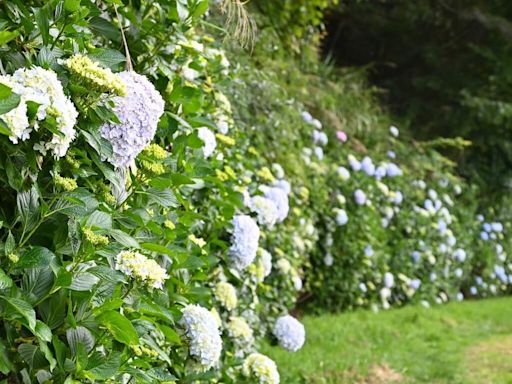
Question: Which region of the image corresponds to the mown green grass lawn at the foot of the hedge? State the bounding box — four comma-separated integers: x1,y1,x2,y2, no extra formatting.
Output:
264,298,512,384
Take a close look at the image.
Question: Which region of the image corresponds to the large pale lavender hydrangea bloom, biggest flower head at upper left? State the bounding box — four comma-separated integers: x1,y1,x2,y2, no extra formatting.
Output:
100,71,164,168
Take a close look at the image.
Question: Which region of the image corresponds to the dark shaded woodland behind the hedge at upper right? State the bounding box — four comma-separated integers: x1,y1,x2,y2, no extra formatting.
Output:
323,0,512,193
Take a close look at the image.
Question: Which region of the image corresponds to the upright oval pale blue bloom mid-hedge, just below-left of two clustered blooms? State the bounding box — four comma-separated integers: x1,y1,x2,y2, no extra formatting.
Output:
229,215,260,270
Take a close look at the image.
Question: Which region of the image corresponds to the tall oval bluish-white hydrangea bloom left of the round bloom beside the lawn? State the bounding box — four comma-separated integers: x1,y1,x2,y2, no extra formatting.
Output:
181,304,222,370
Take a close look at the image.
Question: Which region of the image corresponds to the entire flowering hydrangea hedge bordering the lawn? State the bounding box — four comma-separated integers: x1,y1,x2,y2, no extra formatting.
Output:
0,0,508,383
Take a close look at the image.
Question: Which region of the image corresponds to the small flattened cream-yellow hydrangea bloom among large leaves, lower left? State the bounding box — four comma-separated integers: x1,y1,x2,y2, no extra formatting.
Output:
115,251,169,289
